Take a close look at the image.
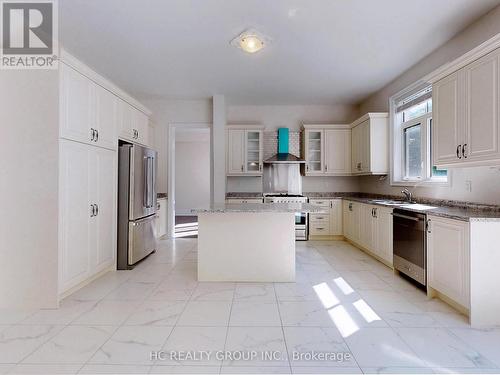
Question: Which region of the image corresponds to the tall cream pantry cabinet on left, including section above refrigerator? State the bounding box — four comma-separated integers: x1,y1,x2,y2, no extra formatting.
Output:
58,53,149,298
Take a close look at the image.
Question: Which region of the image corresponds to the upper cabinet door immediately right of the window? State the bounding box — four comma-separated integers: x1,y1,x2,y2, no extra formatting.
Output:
432,72,463,166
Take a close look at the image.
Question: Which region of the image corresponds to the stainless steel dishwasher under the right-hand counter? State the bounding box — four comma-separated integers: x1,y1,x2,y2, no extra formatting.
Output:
392,208,427,286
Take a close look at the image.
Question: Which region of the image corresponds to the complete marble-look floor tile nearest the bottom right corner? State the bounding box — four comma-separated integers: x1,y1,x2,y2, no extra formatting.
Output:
396,328,494,368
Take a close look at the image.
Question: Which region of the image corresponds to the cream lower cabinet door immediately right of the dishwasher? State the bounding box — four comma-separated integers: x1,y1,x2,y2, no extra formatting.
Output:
427,216,470,307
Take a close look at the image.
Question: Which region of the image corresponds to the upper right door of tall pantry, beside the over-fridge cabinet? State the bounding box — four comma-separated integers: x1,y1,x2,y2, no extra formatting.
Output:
94,85,118,150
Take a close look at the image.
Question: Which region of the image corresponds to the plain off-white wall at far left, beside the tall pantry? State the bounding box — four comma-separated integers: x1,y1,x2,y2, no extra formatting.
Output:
0,70,59,308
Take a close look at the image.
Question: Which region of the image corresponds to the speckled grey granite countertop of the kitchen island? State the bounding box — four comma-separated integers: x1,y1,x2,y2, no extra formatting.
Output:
191,203,327,214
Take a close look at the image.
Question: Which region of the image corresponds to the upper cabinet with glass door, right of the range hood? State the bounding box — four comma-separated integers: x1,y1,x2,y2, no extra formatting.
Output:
302,124,351,176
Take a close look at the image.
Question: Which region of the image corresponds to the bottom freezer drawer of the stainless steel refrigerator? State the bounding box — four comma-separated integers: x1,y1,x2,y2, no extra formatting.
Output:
128,215,156,266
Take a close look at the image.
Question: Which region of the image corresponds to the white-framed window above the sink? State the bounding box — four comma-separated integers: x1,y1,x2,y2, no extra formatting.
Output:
391,87,448,184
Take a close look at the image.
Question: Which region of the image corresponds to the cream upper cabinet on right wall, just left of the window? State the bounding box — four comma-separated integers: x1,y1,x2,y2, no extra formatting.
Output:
351,113,389,175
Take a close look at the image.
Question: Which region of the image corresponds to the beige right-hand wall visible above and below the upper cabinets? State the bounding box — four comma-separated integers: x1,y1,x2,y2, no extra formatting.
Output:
359,6,500,204
